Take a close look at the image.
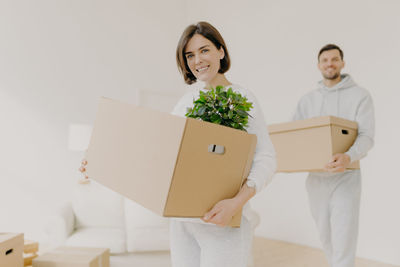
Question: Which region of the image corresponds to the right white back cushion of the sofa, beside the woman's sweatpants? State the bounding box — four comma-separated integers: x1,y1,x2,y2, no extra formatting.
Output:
125,199,169,252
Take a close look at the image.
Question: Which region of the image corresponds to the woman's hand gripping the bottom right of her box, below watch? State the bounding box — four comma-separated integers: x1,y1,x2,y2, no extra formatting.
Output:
202,184,256,226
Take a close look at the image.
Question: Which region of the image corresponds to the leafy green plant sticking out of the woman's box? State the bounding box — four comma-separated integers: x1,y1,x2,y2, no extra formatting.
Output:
186,86,253,131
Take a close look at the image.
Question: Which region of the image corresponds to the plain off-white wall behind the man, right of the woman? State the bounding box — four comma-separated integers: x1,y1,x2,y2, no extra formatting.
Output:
188,0,400,265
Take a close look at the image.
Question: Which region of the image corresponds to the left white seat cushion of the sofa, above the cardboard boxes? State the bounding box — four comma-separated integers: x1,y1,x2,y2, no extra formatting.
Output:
66,227,126,253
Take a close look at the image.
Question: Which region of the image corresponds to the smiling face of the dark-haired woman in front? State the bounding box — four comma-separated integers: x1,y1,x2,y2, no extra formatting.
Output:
184,34,225,84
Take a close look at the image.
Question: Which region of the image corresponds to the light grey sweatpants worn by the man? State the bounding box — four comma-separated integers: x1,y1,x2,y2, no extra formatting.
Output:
306,170,361,267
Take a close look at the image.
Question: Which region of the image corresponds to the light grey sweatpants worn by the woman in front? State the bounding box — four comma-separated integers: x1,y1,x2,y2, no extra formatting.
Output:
170,217,253,267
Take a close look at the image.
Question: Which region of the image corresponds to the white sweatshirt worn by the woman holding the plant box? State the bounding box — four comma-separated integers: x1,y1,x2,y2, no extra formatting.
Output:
172,85,276,222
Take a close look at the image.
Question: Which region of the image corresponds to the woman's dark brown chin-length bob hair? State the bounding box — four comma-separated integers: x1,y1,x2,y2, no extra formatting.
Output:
176,21,231,84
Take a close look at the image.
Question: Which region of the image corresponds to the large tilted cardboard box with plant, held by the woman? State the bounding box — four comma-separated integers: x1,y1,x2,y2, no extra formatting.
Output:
86,98,257,226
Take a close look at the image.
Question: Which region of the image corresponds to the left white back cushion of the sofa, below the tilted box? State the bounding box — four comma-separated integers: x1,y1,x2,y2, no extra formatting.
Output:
72,180,124,229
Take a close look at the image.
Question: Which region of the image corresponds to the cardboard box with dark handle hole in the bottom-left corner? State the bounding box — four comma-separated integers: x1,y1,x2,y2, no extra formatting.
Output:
0,233,24,267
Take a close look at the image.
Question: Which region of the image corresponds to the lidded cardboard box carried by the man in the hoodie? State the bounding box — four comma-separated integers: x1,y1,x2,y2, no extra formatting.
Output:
268,116,360,172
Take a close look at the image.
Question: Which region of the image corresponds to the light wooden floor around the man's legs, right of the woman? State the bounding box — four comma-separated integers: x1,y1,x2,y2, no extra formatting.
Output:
253,237,399,267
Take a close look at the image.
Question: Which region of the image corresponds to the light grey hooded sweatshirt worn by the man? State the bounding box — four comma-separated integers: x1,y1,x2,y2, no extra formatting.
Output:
294,74,375,162
